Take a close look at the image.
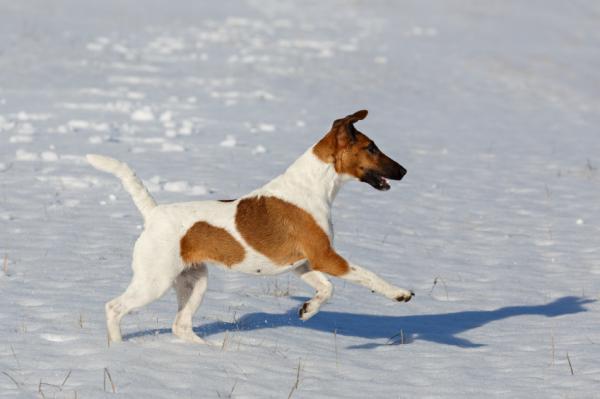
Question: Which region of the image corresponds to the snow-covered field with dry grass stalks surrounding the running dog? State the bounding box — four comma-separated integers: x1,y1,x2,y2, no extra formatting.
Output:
0,0,600,398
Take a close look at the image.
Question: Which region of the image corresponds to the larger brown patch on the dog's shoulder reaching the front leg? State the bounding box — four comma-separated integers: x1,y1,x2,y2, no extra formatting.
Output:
235,197,348,276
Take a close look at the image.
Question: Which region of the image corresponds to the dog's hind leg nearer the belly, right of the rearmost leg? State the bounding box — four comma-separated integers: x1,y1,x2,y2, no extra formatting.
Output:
173,263,208,344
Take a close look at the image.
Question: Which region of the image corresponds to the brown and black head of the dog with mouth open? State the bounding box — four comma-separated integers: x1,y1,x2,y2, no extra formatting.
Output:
313,110,406,190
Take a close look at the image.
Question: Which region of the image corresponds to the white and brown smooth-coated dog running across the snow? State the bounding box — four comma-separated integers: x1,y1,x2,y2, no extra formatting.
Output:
87,110,414,344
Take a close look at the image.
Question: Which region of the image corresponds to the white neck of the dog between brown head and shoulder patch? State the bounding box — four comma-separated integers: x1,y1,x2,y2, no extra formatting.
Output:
264,147,351,207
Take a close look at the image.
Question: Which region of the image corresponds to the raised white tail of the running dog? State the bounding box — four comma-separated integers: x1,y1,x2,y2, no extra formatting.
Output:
86,154,156,221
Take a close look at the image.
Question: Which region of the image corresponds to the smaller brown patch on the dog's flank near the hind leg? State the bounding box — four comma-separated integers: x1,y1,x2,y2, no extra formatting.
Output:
179,222,246,266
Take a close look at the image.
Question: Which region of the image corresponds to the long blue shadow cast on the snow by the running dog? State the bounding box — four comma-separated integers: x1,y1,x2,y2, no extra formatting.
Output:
124,296,595,349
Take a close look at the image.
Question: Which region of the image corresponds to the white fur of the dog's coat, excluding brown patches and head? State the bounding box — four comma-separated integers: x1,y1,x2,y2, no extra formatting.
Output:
87,148,411,343
